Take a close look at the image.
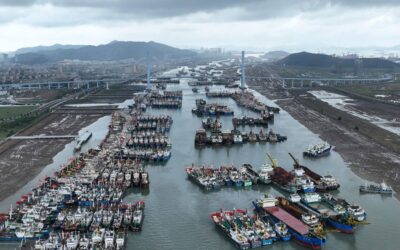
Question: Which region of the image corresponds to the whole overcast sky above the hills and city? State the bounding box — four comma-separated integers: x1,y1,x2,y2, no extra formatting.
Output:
0,0,400,51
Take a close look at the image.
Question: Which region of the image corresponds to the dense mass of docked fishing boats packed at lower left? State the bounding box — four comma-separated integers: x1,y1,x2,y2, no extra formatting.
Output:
0,112,149,250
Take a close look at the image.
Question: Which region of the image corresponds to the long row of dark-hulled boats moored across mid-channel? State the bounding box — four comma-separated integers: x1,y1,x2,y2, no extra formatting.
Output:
194,129,287,146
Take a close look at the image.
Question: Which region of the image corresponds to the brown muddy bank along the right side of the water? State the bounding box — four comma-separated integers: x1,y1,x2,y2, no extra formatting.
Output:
249,84,400,199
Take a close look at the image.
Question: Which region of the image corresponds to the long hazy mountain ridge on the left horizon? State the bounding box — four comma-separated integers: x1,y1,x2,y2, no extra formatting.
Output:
15,41,196,64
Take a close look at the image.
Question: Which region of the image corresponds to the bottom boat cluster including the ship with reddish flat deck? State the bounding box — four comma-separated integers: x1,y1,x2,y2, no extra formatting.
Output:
211,194,365,249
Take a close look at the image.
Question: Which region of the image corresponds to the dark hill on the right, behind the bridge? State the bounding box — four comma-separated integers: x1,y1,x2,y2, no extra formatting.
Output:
277,52,400,69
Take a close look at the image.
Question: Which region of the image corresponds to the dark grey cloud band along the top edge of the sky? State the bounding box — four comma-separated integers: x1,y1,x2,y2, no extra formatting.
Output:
0,0,400,19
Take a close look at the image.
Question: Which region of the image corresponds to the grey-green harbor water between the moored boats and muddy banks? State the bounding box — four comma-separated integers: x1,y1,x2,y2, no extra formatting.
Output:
0,79,400,250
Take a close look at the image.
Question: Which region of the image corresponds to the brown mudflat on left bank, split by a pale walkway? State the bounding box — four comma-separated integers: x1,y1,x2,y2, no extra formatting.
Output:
0,114,103,201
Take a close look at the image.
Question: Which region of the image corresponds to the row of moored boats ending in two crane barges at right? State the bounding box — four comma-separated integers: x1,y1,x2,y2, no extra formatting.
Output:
186,155,340,194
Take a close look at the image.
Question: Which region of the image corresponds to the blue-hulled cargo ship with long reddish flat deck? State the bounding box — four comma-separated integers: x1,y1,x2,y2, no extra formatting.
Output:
253,194,326,249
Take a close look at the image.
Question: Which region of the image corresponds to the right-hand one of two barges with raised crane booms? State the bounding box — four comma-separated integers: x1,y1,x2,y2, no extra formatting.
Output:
289,153,340,192
